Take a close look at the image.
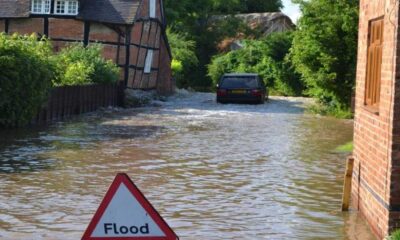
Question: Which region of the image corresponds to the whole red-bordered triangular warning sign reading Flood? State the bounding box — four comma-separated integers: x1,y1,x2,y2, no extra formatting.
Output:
82,173,179,240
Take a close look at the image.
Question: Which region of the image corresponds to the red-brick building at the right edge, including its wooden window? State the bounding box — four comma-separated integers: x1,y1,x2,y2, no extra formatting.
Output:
352,0,400,239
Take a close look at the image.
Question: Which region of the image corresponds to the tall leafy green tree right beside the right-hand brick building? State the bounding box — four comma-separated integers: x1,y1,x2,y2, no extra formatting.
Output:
291,0,359,111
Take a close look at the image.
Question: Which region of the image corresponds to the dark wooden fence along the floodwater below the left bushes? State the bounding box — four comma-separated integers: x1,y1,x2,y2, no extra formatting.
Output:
32,84,124,125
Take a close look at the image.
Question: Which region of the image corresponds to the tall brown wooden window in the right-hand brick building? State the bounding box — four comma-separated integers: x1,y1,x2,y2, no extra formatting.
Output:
365,18,384,111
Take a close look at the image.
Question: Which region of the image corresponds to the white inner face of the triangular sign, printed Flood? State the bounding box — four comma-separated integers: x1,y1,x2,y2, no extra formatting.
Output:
92,183,165,237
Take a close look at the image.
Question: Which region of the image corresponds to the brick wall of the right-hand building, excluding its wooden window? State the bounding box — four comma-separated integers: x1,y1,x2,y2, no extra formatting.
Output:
352,0,400,238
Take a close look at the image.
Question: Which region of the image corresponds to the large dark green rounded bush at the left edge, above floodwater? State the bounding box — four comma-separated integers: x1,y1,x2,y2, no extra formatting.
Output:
0,34,54,128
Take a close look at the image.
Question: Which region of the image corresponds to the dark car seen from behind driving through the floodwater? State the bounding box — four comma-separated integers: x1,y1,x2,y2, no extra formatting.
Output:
217,73,268,104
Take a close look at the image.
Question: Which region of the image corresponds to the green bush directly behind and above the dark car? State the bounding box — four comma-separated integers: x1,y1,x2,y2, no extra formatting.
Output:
208,32,304,96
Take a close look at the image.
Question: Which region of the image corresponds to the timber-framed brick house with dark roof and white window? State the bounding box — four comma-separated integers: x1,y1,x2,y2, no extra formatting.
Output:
0,0,174,94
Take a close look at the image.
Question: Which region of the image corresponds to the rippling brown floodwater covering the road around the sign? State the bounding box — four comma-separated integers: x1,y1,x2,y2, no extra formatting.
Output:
0,92,374,240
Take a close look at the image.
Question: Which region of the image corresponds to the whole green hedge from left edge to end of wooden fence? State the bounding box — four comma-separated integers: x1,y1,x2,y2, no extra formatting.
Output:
0,34,119,128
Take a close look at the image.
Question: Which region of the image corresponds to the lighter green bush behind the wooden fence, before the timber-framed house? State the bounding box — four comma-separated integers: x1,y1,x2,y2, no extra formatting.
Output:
53,44,119,86
